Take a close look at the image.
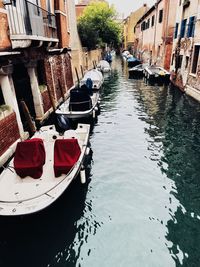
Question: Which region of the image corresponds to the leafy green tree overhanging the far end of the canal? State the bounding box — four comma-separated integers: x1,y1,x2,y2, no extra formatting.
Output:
78,1,121,49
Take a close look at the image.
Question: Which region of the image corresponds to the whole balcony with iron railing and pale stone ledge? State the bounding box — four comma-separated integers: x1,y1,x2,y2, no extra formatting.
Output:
4,0,58,48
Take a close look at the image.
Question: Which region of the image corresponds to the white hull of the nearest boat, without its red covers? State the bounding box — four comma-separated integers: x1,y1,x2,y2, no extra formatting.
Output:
0,124,90,216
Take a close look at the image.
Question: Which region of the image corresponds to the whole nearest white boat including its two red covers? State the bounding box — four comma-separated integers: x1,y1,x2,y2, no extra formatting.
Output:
0,124,90,216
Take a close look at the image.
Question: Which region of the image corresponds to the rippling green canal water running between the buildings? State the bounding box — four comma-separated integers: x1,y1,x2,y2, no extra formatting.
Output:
0,59,200,267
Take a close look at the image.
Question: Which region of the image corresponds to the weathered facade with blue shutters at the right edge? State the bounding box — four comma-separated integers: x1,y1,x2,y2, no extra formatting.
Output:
171,0,200,101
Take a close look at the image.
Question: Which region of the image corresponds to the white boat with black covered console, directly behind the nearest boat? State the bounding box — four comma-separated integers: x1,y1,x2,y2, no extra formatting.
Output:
55,86,99,119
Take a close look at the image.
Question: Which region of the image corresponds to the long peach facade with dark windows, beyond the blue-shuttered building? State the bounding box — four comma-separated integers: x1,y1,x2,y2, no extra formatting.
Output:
135,0,179,70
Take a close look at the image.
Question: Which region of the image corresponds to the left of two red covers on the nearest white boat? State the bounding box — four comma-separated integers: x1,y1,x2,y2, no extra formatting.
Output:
14,138,45,178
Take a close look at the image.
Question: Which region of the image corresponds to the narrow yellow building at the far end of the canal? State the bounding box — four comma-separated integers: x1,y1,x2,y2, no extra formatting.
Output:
123,4,148,50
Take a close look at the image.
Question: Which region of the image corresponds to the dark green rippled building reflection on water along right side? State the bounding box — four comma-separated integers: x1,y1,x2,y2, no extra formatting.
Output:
135,79,200,267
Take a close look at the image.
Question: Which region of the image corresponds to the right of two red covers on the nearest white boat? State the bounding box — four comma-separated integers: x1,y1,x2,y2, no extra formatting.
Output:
54,138,81,177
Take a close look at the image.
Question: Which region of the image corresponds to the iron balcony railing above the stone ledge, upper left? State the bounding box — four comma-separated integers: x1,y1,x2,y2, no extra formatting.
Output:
4,0,57,39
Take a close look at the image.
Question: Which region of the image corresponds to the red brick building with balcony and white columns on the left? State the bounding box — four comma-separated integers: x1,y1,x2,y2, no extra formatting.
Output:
0,0,75,165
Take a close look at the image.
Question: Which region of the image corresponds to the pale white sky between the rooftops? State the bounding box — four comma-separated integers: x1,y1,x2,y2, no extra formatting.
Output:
75,0,156,18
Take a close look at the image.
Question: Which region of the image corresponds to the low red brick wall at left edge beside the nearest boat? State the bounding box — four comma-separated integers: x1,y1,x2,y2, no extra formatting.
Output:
0,112,20,156
